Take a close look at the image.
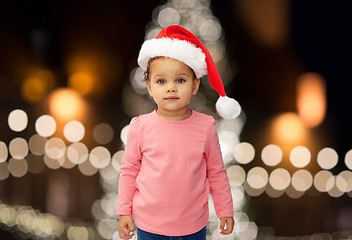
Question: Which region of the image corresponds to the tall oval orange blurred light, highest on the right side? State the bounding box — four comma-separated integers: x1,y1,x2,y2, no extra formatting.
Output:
297,73,326,127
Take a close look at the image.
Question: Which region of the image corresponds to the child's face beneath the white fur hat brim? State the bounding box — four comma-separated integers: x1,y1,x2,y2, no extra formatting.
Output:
146,57,200,119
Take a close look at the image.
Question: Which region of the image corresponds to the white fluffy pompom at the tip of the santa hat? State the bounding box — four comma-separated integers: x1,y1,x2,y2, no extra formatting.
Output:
215,96,241,119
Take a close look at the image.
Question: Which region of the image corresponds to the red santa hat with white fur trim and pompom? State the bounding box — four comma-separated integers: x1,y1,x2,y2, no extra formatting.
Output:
138,25,241,119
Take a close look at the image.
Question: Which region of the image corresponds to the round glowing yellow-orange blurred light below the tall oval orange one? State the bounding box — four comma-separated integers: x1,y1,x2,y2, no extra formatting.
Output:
273,113,306,143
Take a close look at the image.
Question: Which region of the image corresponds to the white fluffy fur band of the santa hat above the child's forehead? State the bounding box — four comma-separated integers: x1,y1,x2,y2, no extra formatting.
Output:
138,38,207,78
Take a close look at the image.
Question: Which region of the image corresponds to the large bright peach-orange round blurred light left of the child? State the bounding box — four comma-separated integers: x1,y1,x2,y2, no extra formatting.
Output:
49,88,85,121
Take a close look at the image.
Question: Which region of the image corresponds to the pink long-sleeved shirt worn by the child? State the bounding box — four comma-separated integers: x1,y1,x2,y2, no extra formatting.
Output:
117,111,234,236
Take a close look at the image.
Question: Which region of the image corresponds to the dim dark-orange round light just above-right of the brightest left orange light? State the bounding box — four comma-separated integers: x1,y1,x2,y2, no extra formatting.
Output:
68,72,95,95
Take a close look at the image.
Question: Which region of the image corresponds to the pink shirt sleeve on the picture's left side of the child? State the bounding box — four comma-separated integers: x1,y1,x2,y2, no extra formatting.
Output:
116,118,142,215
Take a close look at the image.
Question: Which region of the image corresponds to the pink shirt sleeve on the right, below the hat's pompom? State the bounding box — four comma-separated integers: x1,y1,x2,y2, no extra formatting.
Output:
206,119,234,218
